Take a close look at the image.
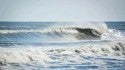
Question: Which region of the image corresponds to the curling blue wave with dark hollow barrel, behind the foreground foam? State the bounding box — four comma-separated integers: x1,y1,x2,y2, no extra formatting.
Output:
0,23,107,41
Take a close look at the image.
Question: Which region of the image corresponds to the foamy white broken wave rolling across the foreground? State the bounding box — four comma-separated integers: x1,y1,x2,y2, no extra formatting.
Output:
0,42,125,65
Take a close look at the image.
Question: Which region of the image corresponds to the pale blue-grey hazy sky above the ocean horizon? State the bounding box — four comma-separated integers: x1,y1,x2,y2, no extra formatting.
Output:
0,0,125,22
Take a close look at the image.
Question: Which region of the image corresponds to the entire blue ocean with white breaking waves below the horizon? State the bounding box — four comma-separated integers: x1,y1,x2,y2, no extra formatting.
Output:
0,22,125,70
